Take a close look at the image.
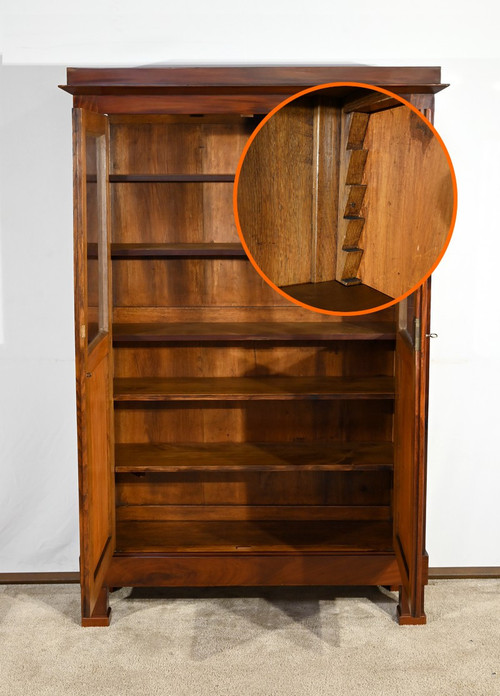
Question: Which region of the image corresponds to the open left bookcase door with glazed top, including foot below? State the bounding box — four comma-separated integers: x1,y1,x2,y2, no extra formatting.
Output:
73,110,115,625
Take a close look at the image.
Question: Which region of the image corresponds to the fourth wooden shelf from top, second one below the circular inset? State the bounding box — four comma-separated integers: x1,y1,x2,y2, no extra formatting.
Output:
114,377,394,401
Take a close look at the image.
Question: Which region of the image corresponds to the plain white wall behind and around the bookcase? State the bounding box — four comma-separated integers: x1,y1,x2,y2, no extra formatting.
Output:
0,0,500,572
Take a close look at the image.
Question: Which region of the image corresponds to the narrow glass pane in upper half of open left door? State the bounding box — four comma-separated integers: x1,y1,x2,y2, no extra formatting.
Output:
85,134,107,344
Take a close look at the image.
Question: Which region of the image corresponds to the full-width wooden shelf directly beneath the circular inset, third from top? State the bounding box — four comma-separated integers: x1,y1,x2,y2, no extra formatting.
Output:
113,321,395,345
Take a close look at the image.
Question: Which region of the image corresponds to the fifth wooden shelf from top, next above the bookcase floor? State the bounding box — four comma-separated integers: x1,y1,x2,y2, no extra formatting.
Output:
115,442,394,473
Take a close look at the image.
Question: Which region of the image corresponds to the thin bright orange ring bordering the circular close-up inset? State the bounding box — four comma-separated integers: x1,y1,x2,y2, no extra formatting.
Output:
233,82,458,317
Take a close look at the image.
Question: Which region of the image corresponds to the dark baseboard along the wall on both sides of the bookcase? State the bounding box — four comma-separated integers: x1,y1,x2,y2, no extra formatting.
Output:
0,566,500,585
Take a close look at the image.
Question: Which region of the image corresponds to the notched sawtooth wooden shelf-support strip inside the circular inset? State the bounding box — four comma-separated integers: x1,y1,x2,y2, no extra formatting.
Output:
336,111,370,285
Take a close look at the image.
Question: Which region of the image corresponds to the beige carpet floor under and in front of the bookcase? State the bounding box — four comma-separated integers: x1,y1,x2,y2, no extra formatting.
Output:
0,580,500,696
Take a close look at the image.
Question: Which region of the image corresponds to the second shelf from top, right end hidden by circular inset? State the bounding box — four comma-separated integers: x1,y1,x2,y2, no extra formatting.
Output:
111,242,247,259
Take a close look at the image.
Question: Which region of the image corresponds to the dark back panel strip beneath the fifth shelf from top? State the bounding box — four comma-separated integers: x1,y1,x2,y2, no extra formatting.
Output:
116,471,392,506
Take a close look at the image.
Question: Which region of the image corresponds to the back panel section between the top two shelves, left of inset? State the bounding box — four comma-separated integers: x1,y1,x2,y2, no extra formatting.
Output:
111,181,239,243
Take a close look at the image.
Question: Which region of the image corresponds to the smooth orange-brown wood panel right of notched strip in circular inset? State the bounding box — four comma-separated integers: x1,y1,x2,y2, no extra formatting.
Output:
360,107,453,297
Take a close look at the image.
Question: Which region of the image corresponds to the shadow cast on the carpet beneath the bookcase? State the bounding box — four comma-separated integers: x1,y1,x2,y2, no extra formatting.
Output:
119,586,397,661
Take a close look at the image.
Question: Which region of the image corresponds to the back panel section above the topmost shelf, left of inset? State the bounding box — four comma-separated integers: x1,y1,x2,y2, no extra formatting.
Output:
110,115,257,174
